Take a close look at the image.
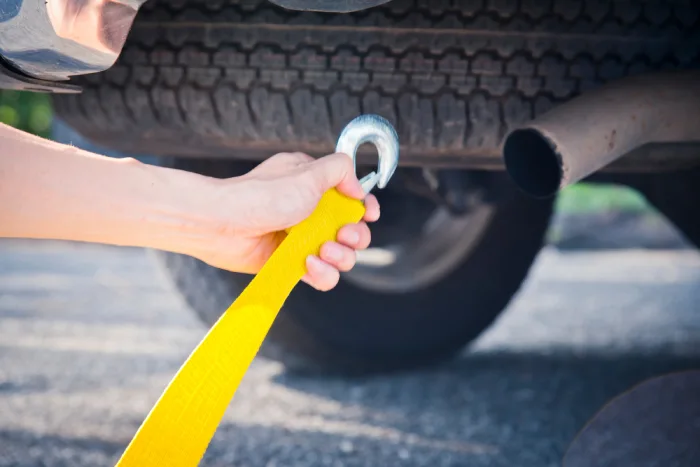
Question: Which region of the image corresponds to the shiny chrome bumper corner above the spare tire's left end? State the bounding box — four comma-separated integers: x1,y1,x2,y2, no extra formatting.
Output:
0,0,145,81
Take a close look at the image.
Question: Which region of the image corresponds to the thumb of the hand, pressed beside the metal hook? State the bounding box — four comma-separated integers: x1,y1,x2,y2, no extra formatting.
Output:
308,153,365,199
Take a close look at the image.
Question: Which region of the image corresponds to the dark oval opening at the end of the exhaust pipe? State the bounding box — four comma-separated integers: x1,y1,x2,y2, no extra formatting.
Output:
503,128,563,198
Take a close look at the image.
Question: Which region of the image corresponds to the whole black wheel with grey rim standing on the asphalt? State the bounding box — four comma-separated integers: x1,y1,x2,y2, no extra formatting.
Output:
156,160,552,373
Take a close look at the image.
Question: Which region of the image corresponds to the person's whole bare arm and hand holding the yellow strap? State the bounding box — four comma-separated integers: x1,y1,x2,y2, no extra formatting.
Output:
0,124,379,291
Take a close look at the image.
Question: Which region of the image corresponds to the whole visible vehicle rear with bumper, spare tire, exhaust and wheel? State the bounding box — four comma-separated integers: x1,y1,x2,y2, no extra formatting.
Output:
0,0,700,371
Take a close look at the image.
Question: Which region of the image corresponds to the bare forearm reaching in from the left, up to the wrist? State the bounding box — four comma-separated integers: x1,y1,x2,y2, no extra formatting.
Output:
0,124,221,251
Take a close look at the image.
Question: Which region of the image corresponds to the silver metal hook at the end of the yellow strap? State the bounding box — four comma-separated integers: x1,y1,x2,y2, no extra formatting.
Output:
335,114,399,193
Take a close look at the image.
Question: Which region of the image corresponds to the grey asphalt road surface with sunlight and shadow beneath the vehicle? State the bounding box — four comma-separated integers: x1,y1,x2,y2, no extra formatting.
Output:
0,241,700,467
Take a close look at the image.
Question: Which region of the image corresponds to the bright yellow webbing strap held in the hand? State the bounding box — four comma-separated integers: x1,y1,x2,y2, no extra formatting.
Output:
117,189,365,467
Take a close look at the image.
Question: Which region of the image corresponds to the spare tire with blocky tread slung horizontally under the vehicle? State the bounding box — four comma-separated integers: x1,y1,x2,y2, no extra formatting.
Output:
55,0,700,159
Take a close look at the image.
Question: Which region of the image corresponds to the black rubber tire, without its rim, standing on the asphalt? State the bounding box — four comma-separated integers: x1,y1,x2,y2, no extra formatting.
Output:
155,160,552,373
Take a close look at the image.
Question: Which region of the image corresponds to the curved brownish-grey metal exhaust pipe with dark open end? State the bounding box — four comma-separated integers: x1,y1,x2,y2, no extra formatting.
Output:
503,71,700,198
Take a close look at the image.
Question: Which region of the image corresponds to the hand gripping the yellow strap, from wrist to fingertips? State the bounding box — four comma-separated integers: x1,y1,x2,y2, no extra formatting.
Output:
193,153,379,291
